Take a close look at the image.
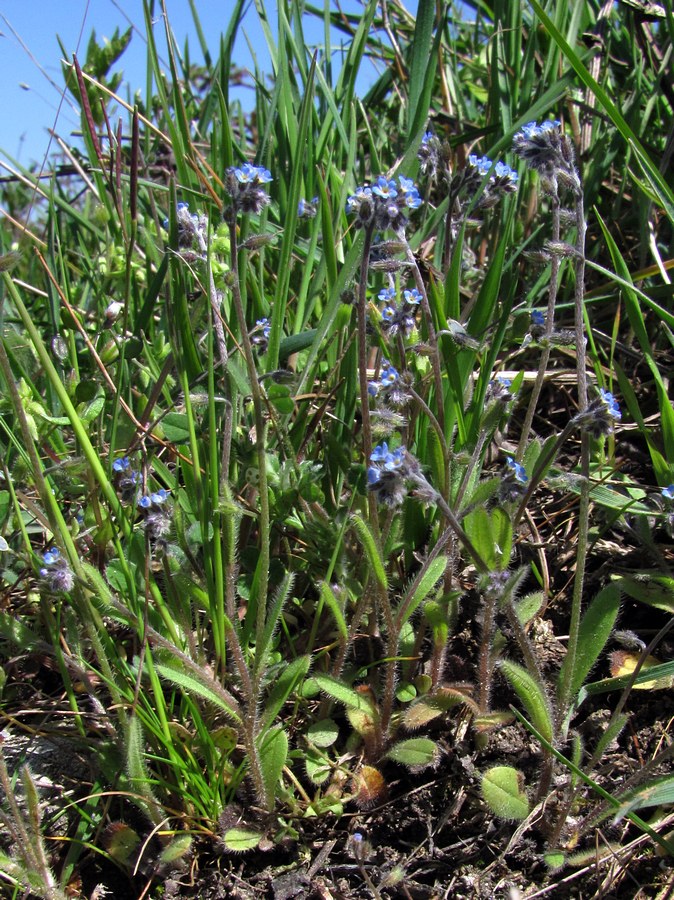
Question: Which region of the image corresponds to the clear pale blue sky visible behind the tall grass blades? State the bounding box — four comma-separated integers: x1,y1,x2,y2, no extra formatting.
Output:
0,0,417,165
